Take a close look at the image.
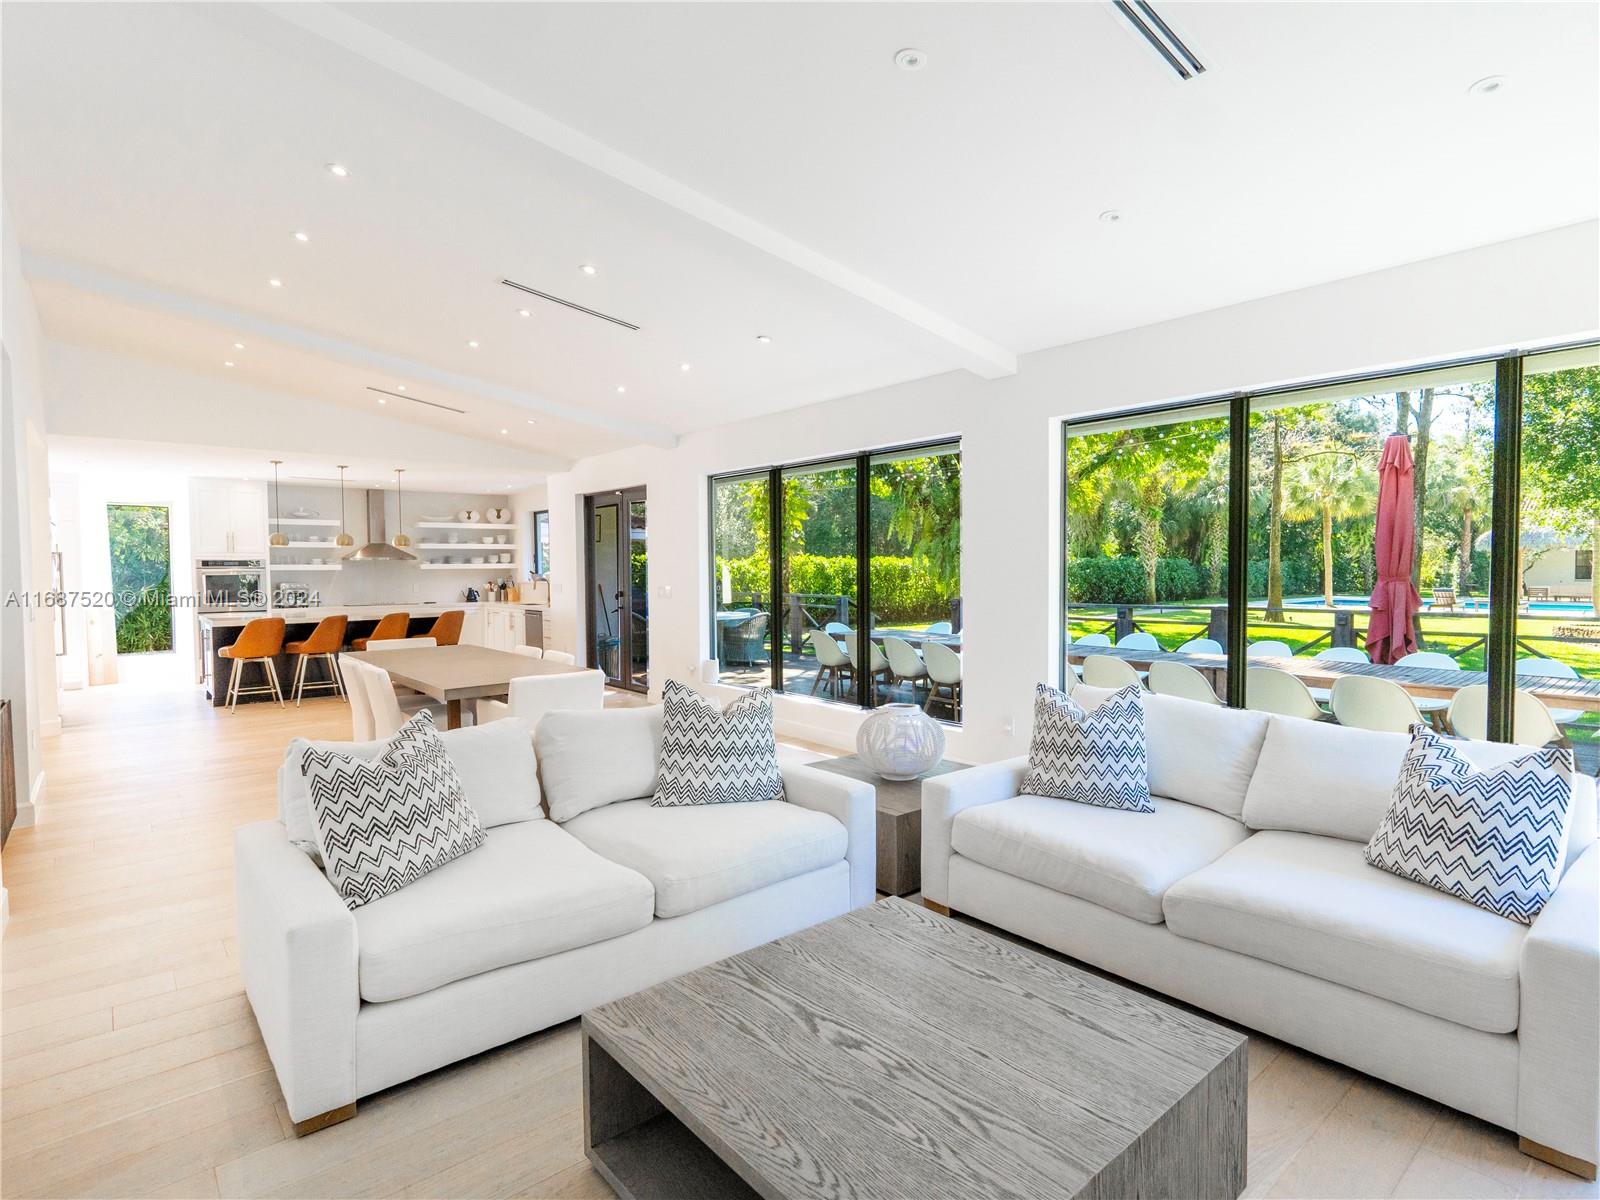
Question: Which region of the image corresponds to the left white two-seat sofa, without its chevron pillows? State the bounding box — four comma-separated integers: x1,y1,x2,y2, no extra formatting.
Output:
234,707,877,1133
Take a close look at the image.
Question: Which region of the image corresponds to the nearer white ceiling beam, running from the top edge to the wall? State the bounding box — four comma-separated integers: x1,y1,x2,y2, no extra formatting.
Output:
264,3,1016,379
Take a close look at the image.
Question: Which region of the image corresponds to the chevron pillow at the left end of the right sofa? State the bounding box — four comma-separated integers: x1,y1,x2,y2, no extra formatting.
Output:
1022,683,1155,813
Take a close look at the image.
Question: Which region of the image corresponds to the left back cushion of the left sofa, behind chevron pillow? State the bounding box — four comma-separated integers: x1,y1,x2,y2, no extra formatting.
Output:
278,722,544,858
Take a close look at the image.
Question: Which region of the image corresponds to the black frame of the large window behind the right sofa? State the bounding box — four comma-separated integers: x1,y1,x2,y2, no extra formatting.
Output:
1056,338,1600,742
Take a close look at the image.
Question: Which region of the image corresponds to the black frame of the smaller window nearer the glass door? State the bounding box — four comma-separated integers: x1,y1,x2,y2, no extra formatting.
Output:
706,434,966,725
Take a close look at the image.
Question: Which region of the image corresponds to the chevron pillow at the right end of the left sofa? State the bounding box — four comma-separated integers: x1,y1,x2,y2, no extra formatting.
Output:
651,680,784,808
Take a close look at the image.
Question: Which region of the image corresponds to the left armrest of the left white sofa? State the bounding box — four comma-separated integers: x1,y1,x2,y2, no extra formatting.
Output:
234,821,362,1122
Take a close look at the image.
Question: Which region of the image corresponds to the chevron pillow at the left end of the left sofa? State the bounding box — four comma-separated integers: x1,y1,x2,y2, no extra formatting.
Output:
301,712,483,909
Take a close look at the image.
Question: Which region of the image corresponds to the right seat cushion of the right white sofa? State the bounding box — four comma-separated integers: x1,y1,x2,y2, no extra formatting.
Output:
1163,832,1528,1034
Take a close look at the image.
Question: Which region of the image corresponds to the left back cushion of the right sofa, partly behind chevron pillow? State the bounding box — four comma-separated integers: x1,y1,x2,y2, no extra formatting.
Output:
1072,685,1267,819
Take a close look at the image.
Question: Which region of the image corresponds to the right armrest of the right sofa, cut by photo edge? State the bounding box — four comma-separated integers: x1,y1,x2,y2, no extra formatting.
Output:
1517,843,1600,1163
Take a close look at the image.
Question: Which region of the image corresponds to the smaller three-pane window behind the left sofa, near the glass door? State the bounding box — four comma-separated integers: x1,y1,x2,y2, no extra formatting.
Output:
710,443,962,722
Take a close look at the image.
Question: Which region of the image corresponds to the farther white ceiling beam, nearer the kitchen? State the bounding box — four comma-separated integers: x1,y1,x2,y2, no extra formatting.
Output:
22,251,677,454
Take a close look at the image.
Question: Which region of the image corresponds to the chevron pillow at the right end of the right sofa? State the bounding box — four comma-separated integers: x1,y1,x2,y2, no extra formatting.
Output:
1366,725,1573,925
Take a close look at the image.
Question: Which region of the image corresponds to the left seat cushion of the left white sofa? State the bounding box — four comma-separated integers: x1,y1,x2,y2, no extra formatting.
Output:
355,821,654,1003
